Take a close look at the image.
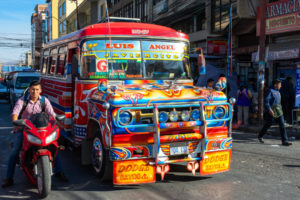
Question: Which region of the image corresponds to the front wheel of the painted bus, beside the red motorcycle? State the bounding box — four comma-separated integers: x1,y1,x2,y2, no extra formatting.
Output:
91,136,112,183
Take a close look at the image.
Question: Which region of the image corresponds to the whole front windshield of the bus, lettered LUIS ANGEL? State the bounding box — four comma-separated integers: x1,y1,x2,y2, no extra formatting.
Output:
80,40,190,79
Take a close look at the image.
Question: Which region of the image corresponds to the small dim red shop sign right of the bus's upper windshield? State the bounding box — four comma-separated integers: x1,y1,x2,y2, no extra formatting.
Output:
206,38,227,55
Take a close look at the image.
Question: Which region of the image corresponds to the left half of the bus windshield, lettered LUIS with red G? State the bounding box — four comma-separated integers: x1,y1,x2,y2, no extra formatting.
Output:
80,40,142,79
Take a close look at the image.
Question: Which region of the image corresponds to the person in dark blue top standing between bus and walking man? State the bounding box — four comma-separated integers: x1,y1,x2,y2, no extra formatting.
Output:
236,85,252,127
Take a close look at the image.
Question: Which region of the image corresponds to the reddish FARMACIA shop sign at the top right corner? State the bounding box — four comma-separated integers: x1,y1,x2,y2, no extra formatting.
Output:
257,0,300,35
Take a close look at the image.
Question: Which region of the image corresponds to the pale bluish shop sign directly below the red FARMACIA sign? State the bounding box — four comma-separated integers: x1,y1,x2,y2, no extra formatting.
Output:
252,49,299,62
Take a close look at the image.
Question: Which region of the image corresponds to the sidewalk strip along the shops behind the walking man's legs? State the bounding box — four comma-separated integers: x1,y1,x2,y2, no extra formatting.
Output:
233,124,300,140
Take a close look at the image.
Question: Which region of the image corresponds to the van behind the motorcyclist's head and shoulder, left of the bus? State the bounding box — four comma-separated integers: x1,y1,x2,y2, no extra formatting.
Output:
9,72,40,108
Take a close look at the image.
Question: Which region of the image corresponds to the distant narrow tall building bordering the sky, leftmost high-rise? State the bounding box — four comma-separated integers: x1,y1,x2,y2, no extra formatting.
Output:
31,4,48,69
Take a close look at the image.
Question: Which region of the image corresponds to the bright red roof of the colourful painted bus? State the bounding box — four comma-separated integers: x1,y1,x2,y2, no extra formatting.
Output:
46,22,189,46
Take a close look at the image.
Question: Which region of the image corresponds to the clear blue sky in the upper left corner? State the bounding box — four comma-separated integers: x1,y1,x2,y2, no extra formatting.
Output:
0,0,46,64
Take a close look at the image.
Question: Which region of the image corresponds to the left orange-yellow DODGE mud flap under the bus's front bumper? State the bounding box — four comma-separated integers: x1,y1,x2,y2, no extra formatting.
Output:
113,160,156,185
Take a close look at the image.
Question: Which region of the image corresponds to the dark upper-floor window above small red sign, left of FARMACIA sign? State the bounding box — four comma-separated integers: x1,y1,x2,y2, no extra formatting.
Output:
212,0,237,32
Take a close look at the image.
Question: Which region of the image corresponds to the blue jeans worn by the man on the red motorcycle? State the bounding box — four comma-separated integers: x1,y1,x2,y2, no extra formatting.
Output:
6,132,62,179
